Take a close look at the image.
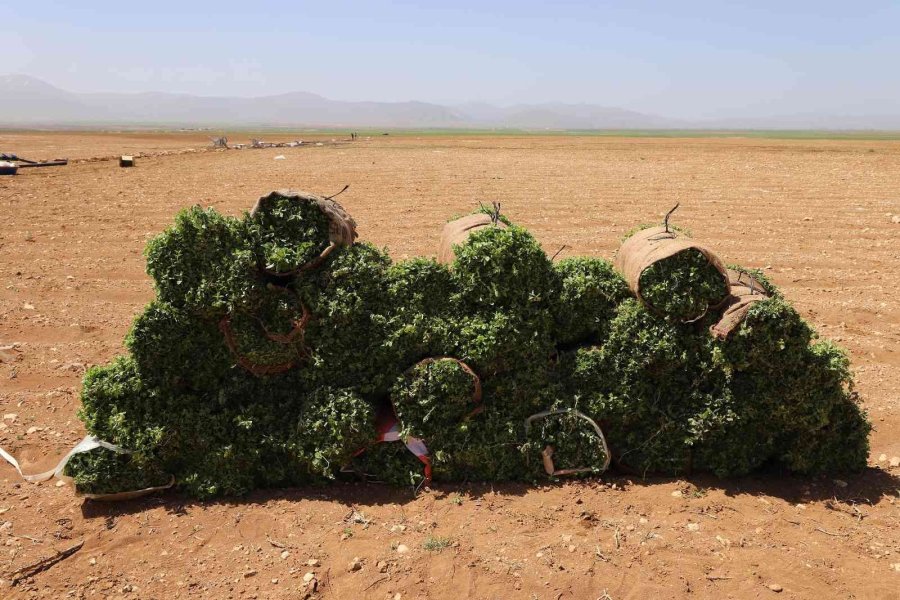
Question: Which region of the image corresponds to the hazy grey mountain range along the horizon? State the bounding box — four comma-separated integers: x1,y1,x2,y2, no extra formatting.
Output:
0,75,900,130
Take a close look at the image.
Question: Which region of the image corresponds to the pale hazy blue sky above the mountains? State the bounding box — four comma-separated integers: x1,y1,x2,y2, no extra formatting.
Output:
0,0,900,118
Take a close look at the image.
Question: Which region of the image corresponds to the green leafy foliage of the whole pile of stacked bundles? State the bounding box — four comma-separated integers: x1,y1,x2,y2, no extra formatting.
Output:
66,197,870,498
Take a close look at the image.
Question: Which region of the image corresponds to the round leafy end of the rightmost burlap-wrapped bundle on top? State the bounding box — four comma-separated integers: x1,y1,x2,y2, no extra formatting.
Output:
640,248,728,321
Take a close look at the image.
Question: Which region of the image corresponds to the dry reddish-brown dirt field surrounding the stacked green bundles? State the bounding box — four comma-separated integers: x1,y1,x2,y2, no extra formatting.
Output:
0,132,900,600
